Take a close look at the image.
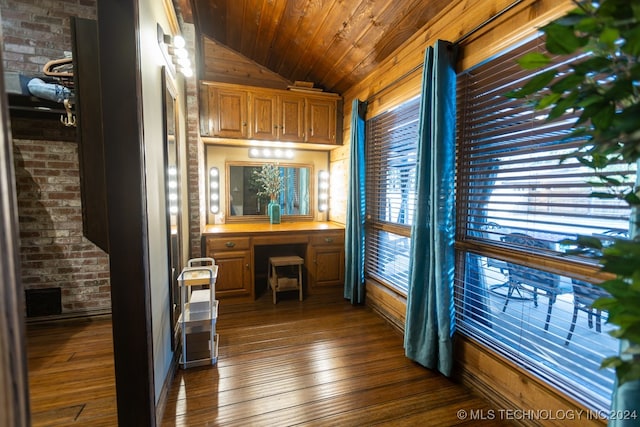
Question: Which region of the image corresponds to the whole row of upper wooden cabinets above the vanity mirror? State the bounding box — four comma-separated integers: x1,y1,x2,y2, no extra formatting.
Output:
200,82,340,145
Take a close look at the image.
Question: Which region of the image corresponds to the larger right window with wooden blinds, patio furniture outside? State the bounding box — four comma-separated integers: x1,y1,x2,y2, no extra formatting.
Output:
456,40,635,410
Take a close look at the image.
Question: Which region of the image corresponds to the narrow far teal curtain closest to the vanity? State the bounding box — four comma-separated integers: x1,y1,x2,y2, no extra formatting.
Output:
344,99,367,304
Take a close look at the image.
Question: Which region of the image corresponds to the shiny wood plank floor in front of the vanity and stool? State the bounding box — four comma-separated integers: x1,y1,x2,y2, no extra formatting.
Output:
162,292,499,427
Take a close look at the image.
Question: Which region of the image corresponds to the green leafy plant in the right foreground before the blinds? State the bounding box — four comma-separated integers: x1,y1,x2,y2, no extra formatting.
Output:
506,0,640,425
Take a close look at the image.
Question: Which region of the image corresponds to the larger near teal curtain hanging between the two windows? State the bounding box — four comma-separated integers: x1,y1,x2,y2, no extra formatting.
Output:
404,40,457,376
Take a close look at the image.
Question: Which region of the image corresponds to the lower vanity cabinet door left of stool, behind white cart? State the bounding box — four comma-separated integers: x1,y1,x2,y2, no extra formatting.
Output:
213,251,253,299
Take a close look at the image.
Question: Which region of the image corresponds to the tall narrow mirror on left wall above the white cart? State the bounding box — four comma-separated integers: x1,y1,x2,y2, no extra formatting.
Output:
162,67,182,350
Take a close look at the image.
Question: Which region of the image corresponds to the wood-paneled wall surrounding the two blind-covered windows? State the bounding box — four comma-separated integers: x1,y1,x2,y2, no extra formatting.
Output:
331,0,601,425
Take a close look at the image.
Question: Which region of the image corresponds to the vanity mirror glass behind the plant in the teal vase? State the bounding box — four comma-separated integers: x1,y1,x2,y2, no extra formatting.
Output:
227,163,312,218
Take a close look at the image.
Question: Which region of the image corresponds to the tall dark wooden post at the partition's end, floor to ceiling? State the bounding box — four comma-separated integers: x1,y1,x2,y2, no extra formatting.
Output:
98,0,156,426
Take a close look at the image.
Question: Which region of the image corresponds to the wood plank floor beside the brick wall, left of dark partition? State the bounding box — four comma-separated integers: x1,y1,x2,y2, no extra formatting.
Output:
27,316,118,427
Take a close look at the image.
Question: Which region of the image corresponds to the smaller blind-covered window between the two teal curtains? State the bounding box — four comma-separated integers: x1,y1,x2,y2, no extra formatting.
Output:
365,98,420,293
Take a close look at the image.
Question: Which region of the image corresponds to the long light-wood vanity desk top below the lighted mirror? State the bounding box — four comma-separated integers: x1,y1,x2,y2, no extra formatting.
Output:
202,221,344,236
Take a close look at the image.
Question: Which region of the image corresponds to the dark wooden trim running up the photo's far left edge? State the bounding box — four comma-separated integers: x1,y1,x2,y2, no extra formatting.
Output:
0,46,31,427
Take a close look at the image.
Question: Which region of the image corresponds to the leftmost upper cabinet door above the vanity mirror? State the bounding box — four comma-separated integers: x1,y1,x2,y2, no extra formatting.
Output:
209,88,248,138
